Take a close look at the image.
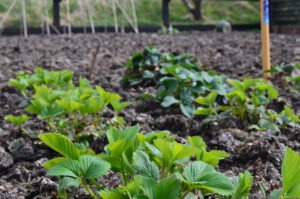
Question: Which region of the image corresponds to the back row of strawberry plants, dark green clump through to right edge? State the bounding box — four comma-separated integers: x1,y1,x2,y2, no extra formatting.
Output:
122,47,300,131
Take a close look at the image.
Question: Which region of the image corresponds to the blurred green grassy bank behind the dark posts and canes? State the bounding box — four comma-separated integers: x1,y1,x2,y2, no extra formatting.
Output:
0,0,259,27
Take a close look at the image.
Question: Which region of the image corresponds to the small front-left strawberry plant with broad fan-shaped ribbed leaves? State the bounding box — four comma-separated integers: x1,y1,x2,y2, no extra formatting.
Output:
39,133,110,198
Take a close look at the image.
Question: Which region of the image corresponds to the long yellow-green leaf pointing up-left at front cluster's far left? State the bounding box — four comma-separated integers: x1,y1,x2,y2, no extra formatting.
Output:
39,133,80,160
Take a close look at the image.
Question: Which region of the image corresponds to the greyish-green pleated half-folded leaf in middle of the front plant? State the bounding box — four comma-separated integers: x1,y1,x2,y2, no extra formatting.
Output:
133,151,159,180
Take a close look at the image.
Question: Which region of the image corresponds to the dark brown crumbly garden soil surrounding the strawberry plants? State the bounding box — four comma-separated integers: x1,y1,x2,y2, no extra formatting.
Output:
0,32,300,199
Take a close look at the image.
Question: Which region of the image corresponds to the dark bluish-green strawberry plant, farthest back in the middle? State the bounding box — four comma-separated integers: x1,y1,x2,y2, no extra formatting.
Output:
123,47,228,118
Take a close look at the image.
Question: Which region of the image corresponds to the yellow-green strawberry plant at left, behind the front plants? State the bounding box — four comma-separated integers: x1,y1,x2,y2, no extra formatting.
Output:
7,68,130,139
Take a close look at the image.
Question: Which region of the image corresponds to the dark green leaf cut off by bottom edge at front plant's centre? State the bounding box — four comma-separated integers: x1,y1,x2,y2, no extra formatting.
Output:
141,178,180,199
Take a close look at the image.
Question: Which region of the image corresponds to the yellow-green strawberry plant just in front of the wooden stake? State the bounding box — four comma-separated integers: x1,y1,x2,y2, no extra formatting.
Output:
227,79,279,131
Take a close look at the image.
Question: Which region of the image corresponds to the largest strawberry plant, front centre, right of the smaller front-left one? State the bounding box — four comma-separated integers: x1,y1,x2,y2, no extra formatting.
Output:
100,127,252,199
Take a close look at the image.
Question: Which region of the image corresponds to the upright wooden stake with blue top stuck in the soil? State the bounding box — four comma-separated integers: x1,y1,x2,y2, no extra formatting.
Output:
260,0,271,78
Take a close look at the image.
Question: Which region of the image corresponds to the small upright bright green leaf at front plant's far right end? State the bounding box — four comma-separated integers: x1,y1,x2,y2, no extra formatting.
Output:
232,171,253,199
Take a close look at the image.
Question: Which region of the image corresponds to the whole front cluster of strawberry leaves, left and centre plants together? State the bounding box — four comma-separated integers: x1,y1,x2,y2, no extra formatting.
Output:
40,126,252,199
